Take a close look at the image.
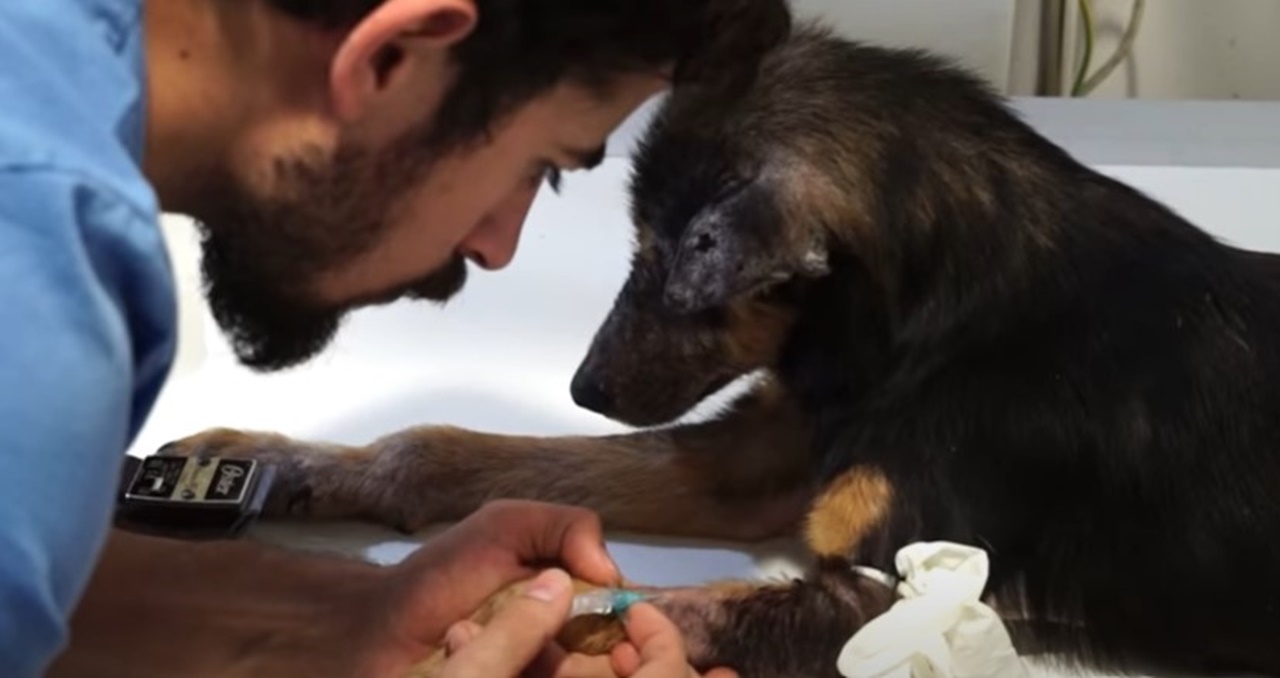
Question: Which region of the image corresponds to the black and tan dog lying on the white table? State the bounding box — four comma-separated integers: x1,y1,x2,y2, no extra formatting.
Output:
157,27,1280,677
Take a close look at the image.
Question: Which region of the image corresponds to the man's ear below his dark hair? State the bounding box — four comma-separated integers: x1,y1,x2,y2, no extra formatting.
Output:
329,0,477,122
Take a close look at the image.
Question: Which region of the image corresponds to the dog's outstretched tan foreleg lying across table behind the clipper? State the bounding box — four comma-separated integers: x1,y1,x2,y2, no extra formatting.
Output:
154,376,813,540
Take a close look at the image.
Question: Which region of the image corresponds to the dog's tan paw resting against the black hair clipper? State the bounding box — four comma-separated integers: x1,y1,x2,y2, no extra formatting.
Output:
156,429,344,518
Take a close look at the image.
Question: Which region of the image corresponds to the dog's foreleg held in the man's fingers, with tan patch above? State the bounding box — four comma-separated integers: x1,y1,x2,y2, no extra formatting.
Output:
415,466,896,678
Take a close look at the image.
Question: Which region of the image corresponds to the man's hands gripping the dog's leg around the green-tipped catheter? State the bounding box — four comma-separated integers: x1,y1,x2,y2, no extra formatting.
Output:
358,501,733,678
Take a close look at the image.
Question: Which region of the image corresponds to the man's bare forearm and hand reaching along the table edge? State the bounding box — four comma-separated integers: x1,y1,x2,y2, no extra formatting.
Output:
47,493,721,678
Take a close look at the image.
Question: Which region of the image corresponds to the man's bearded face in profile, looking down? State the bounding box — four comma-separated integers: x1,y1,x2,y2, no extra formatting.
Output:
200,74,664,370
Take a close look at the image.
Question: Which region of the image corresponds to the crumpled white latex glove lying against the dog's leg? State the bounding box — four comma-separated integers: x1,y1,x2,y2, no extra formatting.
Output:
837,541,1029,678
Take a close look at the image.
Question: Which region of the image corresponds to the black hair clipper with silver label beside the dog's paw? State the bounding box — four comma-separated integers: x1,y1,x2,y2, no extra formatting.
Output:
115,455,275,540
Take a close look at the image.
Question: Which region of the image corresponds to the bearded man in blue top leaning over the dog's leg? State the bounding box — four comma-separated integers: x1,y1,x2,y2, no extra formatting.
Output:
0,0,788,677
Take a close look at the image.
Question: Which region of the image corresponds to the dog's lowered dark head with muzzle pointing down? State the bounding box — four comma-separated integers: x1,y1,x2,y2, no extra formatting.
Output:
571,85,827,426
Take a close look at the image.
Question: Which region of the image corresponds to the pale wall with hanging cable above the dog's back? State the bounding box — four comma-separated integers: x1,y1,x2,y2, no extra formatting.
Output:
792,0,1280,101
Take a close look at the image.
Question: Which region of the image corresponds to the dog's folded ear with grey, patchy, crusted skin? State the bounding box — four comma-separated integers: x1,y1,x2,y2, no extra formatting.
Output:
663,182,827,313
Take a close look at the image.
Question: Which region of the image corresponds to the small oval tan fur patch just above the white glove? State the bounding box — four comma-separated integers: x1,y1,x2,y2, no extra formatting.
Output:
805,467,893,558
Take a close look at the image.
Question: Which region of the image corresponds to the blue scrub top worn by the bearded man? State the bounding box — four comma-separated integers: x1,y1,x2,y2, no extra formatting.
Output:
0,0,177,678
